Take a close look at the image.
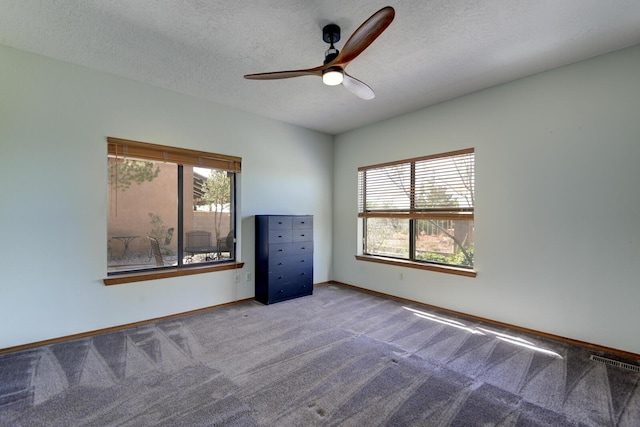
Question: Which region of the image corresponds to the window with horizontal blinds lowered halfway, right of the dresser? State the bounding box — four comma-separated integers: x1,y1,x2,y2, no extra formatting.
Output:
358,148,475,275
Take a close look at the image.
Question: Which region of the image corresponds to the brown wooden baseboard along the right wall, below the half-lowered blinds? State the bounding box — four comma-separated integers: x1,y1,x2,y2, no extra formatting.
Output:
327,281,640,363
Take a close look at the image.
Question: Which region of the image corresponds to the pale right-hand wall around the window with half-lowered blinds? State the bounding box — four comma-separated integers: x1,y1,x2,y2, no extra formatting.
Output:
333,46,640,353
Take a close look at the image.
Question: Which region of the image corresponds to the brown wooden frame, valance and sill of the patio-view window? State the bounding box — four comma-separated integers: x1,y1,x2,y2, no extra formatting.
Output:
103,137,244,285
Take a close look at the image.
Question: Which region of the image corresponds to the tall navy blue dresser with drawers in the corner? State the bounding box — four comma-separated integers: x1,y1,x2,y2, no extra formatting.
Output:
255,215,313,304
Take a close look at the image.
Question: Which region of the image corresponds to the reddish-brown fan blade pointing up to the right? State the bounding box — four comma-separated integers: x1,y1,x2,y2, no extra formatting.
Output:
331,6,396,68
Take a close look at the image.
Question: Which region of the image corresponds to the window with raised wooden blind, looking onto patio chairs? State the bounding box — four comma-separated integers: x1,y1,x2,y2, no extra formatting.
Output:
105,138,241,284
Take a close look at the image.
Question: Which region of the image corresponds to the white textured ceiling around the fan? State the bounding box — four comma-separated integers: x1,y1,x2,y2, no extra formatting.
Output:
0,0,640,134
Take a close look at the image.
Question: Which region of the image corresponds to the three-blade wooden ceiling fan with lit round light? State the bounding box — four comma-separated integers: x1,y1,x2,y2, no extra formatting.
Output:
244,6,395,99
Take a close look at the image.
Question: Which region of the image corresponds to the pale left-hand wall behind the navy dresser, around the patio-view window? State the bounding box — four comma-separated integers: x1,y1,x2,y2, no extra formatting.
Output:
0,46,333,348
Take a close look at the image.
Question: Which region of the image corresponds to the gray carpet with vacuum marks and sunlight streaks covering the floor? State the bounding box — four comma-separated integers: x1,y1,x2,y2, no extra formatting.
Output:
0,285,640,427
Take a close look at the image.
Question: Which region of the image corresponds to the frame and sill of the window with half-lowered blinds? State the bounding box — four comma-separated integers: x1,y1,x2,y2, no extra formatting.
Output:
356,148,477,277
